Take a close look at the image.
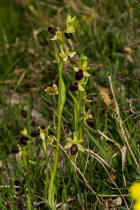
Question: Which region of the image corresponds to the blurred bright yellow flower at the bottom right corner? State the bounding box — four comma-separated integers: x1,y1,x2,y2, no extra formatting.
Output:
129,182,140,210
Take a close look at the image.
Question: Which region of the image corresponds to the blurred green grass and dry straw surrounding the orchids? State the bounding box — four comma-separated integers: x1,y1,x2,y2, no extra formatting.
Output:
0,0,140,210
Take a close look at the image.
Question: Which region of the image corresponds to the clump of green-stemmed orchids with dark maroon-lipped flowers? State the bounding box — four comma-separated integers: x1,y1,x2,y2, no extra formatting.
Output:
19,14,92,209
